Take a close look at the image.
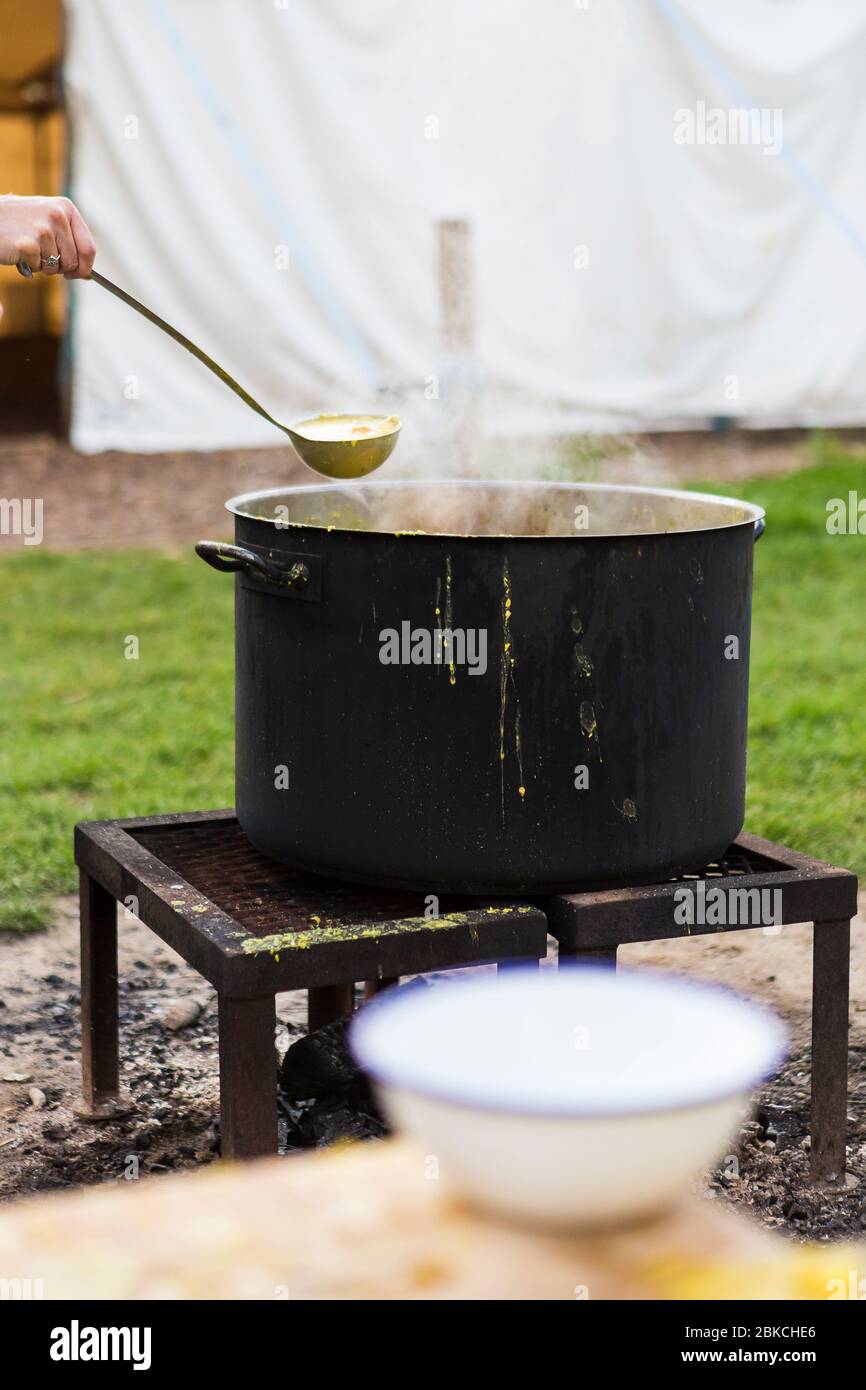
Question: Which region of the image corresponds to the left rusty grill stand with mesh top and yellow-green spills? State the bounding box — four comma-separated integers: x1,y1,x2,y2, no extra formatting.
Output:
75,810,548,1158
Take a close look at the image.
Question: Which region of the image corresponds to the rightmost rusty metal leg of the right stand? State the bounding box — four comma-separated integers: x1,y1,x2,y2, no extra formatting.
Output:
810,922,851,1183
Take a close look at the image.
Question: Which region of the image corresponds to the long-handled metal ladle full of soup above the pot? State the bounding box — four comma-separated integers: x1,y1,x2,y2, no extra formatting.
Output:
18,261,402,478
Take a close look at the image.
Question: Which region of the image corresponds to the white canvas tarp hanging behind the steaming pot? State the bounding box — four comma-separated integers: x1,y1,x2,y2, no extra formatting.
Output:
65,0,866,450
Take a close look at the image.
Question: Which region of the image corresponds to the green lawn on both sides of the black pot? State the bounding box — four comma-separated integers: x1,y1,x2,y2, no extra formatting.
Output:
0,436,866,930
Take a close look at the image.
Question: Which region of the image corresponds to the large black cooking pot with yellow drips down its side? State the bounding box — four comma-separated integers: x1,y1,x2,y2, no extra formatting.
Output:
197,482,763,894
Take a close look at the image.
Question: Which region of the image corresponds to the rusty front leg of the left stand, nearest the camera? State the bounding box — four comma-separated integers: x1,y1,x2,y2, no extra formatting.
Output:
220,994,277,1158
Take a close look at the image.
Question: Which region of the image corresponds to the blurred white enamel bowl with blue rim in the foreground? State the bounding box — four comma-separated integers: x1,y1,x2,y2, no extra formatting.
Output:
352,967,785,1227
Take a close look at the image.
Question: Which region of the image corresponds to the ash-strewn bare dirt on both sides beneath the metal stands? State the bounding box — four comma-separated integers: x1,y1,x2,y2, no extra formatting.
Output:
0,898,866,1240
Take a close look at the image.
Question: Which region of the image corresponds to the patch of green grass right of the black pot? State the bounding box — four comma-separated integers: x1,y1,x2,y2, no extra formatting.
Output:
697,435,866,874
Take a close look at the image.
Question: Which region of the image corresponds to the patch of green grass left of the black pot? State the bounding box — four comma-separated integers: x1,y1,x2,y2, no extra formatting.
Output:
0,548,234,930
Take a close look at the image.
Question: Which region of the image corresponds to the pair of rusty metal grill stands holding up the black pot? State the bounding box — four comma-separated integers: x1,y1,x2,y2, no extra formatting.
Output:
75,810,858,1183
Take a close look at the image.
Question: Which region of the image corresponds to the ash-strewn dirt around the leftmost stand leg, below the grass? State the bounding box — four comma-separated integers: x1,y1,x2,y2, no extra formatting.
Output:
0,899,229,1197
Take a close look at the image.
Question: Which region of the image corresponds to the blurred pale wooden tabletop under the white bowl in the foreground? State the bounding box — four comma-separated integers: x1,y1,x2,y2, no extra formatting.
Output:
0,1140,863,1301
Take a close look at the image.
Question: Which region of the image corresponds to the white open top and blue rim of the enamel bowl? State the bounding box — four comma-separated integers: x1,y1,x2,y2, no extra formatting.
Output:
349,966,787,1119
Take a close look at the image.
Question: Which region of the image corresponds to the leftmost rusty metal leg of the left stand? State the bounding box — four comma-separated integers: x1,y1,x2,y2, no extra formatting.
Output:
75,869,132,1120
